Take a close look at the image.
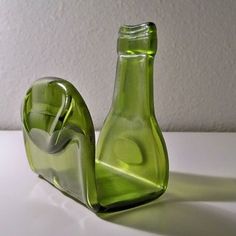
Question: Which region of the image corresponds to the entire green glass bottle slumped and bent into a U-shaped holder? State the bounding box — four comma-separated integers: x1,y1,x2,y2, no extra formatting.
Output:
21,23,168,212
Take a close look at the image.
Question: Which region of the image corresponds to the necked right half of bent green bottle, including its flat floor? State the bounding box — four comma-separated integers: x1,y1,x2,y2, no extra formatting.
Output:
95,23,169,211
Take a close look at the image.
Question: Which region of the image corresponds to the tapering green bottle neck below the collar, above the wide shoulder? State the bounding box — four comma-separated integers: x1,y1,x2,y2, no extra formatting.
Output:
112,54,154,117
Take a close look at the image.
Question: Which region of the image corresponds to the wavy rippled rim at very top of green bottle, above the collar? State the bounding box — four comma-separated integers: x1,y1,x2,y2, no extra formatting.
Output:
119,22,156,39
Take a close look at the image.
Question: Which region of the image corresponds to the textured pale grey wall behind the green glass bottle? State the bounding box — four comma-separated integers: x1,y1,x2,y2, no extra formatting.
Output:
0,0,236,131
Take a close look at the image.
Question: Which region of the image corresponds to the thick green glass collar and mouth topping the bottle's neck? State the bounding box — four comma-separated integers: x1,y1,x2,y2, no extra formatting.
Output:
117,22,157,55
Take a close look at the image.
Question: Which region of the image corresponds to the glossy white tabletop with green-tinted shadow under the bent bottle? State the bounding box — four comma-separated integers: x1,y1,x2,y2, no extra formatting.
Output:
0,131,236,236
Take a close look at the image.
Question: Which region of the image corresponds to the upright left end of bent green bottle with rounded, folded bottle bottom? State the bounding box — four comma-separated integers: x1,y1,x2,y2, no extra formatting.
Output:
21,78,98,211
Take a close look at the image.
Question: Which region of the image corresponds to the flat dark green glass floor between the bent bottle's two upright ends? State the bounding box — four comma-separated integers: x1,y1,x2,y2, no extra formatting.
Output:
96,161,166,212
